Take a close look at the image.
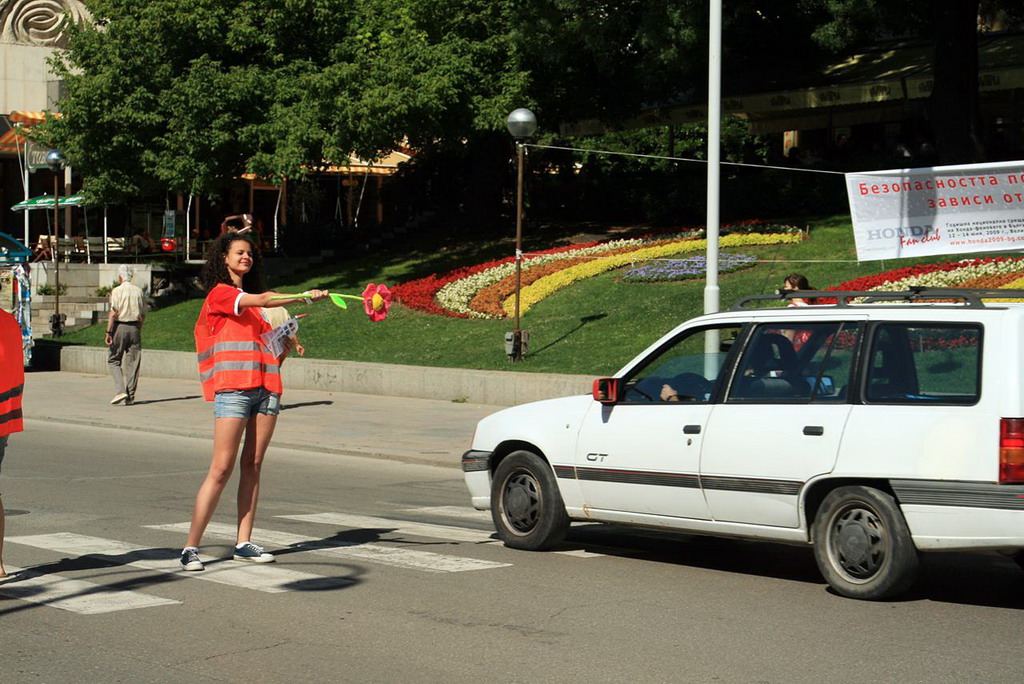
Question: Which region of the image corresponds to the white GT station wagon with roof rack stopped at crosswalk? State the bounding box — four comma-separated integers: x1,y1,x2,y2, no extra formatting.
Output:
462,290,1024,599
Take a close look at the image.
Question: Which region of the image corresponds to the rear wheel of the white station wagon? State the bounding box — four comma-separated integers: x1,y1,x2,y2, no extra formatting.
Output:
814,486,920,600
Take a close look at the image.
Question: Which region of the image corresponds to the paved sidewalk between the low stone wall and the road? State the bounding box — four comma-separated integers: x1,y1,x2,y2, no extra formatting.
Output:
24,372,501,468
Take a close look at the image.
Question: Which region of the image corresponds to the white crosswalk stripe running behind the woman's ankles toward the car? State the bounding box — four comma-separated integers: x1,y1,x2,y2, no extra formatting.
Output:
146,522,510,572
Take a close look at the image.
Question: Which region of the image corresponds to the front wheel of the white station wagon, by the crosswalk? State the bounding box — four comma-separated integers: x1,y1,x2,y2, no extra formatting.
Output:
490,451,569,551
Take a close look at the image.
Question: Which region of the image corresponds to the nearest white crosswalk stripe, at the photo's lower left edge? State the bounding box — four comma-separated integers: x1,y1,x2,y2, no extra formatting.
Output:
0,565,181,615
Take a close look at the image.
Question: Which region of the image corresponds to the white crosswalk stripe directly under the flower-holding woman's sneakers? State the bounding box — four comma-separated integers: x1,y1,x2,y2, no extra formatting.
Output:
6,524,353,594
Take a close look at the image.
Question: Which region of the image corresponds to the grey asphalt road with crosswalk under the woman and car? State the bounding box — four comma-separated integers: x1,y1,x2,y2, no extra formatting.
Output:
0,421,1024,684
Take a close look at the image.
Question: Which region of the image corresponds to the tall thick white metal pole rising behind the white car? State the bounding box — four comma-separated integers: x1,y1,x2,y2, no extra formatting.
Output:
705,0,722,313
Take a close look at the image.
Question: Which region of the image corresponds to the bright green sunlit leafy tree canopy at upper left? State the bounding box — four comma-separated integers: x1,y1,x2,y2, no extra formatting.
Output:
46,0,526,201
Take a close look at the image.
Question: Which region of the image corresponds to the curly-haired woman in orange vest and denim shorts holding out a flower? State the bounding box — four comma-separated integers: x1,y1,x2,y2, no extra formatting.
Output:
181,226,329,570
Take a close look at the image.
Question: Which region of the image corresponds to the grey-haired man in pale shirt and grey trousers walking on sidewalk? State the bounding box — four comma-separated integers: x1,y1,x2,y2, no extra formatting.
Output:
104,263,145,407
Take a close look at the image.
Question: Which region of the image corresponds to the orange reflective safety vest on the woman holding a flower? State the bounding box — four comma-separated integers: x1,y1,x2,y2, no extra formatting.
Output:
196,284,284,401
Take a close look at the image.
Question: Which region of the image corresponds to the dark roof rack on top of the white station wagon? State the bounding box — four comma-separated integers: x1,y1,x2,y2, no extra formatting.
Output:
730,287,1024,311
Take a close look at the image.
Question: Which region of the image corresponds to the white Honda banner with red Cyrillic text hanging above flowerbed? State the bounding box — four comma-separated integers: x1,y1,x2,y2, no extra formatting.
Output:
846,161,1024,261
